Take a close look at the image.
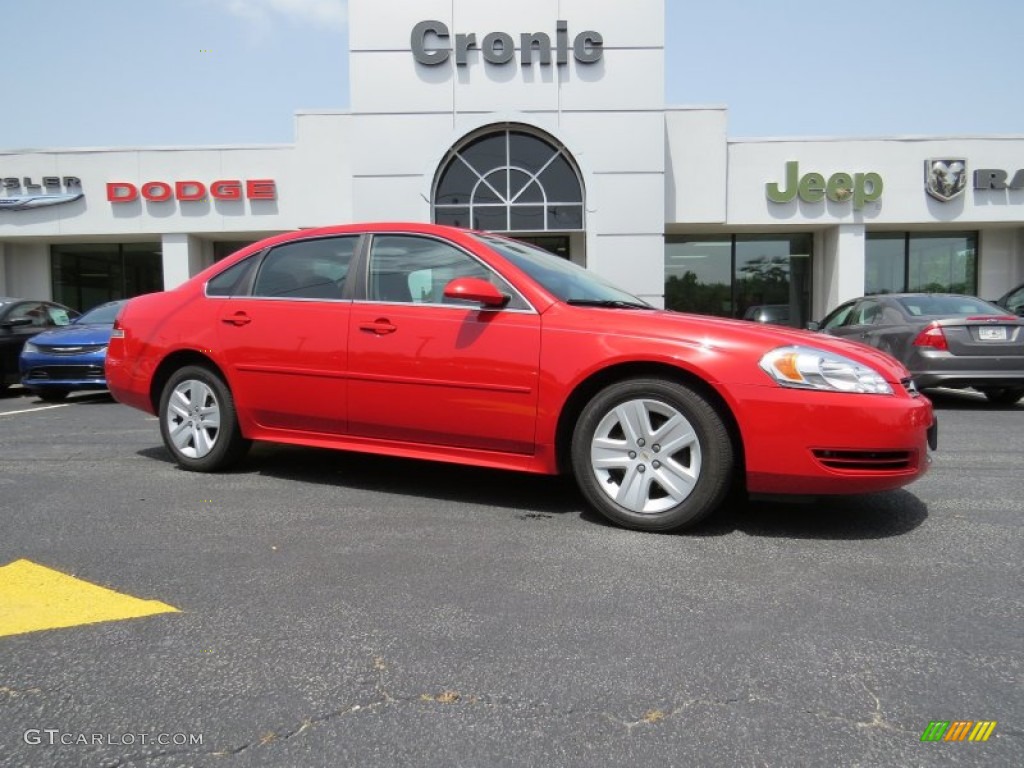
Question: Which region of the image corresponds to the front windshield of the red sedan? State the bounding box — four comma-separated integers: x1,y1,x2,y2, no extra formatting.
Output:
473,233,653,309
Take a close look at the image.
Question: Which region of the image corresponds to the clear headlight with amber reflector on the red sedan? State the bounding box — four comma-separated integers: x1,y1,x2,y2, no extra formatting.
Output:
761,346,893,394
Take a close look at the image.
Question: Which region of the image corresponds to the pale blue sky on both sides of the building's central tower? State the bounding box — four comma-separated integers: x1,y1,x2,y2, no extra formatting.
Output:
0,0,1024,150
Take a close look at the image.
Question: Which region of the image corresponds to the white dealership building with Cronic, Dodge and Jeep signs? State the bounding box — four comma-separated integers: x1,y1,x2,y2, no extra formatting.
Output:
0,0,1024,326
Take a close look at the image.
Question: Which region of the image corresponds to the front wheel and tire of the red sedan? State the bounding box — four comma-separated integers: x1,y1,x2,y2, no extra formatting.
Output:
571,379,735,531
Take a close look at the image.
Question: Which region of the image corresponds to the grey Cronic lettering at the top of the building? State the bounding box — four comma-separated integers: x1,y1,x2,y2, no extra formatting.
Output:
411,19,604,67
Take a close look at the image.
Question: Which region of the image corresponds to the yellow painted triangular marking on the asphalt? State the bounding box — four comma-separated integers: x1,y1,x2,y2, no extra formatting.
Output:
0,560,178,637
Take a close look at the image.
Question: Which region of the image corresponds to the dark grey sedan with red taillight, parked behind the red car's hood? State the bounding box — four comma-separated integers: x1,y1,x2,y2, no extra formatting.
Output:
810,293,1024,404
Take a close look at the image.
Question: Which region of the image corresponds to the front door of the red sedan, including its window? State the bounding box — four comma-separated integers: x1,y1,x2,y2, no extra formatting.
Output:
348,236,541,454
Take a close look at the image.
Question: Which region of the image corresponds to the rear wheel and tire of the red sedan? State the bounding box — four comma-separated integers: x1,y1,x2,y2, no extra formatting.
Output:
160,366,250,472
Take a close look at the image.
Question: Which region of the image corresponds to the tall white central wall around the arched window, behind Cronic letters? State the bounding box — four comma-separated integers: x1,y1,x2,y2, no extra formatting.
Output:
349,0,665,302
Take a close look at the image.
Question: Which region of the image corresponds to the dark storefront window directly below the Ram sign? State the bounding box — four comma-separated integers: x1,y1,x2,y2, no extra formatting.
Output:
864,232,978,296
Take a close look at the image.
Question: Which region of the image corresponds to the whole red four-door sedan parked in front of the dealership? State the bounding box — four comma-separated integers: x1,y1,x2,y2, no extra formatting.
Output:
106,224,935,530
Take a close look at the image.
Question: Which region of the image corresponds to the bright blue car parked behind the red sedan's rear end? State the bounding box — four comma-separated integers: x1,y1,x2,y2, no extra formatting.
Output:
18,299,128,402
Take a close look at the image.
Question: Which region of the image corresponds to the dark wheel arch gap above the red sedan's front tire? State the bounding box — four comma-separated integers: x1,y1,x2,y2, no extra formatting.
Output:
555,361,745,480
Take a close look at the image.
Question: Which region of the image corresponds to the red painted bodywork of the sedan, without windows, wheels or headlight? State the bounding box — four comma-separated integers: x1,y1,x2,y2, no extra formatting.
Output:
106,222,933,494
